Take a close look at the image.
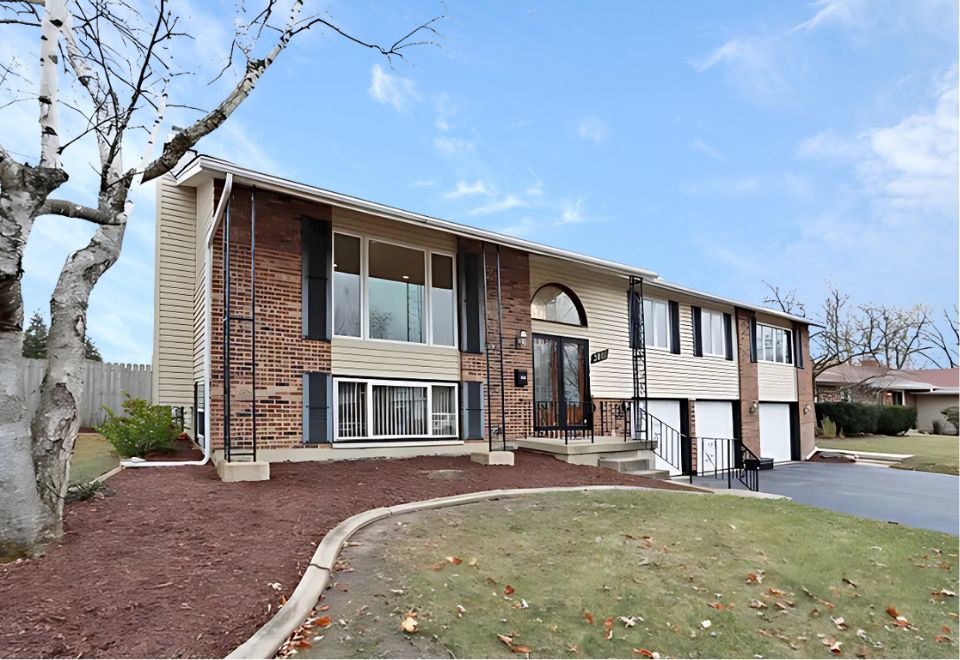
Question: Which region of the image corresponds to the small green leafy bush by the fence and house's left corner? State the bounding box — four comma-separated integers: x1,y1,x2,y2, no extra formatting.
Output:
97,397,178,458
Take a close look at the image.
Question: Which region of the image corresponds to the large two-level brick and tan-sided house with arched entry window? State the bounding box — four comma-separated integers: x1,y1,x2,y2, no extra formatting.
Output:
153,156,815,472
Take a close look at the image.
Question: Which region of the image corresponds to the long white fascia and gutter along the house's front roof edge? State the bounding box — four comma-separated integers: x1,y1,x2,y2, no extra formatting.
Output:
174,155,816,325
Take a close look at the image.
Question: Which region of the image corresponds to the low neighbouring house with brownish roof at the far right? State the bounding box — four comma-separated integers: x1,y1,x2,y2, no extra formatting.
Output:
816,361,960,433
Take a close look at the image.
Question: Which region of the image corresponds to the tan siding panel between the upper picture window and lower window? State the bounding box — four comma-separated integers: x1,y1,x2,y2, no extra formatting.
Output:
331,337,460,381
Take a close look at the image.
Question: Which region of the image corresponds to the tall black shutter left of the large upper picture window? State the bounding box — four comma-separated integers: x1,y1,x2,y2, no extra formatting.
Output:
300,217,333,340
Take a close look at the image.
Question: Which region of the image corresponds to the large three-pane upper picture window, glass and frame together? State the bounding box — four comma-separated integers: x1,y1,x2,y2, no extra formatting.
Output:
333,233,457,346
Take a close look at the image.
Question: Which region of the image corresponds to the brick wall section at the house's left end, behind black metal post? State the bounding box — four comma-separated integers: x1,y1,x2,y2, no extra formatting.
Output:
208,187,330,449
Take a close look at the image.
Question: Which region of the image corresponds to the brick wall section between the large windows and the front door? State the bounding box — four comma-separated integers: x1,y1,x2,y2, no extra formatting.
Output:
459,239,533,440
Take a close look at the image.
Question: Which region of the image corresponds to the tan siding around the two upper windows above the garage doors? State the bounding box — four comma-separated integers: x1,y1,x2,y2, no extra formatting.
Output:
643,285,740,401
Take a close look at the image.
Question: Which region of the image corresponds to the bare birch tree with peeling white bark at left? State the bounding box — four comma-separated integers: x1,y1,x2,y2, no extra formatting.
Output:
0,0,442,561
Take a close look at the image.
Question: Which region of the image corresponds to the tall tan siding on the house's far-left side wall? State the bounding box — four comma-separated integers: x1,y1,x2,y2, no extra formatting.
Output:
153,176,197,405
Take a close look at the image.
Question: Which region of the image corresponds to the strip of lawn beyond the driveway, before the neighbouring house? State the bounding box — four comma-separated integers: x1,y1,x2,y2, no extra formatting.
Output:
817,435,960,474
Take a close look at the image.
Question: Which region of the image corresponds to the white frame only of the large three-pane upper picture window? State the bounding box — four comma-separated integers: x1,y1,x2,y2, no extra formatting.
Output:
330,227,460,349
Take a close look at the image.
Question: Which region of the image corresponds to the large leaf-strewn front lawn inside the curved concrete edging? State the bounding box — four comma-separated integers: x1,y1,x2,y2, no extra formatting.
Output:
301,492,958,658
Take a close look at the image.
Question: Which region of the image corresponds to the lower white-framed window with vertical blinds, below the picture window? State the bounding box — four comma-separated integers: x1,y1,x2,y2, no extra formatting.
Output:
334,379,458,440
